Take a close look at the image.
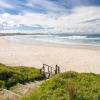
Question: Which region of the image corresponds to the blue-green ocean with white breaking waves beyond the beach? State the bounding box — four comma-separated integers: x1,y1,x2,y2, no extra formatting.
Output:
5,33,100,45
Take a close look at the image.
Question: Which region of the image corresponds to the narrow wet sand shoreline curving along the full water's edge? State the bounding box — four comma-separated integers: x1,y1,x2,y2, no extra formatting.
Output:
3,36,100,50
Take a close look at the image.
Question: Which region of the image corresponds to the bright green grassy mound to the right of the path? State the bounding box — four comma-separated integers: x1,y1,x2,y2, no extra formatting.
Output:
23,72,100,100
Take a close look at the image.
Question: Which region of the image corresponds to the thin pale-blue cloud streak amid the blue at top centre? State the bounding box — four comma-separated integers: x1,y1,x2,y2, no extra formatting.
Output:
27,0,67,13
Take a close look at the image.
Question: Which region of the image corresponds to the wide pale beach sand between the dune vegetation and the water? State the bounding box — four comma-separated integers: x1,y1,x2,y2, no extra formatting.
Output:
0,37,100,73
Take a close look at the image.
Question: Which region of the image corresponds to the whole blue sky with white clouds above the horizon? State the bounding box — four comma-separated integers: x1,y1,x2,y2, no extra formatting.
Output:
0,0,100,34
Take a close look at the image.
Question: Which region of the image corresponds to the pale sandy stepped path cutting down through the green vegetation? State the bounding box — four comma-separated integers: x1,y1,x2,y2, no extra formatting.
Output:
0,81,44,100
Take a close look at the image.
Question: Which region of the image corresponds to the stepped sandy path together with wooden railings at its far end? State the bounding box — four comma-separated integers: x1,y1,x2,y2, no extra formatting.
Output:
0,64,60,100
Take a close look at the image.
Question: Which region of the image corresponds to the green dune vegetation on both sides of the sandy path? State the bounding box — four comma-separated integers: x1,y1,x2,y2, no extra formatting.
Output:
0,64,100,100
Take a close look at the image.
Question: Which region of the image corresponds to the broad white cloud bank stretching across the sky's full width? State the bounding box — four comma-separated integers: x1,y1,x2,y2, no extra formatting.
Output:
0,6,100,33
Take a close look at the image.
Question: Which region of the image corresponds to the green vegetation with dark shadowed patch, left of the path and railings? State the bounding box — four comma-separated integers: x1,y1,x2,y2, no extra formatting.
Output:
0,64,43,89
